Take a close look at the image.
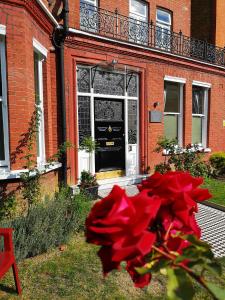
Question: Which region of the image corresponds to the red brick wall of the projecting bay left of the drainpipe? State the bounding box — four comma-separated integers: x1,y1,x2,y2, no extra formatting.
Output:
0,3,58,170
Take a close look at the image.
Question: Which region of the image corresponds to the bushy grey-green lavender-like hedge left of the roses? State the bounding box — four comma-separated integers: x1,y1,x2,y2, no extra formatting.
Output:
0,189,91,260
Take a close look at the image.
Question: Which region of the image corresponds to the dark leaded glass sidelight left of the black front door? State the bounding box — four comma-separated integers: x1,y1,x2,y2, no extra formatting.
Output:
78,96,91,144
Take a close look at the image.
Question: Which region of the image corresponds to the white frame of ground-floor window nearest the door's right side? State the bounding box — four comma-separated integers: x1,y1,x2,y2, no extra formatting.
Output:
164,76,186,147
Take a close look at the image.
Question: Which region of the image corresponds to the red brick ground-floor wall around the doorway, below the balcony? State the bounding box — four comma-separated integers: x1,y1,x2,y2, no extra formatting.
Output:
66,37,225,182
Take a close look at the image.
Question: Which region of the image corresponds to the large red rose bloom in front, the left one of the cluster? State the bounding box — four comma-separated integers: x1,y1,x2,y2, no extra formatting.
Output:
86,186,161,274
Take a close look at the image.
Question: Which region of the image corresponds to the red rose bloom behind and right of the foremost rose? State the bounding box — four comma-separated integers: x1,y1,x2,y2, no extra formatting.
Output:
139,172,211,253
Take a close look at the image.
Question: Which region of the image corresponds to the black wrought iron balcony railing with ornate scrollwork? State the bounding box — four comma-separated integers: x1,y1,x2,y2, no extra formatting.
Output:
80,1,225,67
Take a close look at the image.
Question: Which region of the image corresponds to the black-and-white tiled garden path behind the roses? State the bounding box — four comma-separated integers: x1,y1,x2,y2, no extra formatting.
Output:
99,185,225,257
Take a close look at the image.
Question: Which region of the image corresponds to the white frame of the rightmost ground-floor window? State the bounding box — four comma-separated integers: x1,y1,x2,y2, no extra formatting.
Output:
192,81,211,148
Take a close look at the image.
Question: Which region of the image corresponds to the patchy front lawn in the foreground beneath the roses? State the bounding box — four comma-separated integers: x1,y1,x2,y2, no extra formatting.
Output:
0,234,225,300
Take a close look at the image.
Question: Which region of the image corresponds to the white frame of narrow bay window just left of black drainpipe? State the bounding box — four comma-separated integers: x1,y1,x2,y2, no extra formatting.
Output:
33,39,48,167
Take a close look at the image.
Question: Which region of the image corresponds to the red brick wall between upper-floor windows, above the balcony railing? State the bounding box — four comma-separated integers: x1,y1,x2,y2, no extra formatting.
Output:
69,0,191,36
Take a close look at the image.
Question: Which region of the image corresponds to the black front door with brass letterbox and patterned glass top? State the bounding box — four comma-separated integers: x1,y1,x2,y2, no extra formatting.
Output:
94,98,125,172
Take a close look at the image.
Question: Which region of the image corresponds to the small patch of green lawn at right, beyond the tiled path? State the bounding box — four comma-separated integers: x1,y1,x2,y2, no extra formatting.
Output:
203,178,225,206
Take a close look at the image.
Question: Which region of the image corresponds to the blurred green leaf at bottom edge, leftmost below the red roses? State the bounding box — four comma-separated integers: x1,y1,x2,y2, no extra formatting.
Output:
167,268,194,300
